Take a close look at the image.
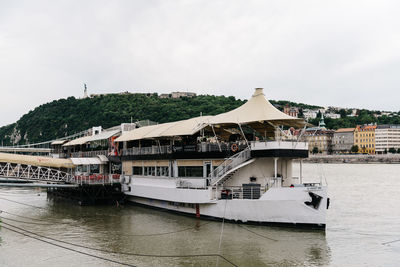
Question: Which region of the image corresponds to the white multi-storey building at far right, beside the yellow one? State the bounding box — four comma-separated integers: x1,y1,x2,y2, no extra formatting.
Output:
375,125,400,154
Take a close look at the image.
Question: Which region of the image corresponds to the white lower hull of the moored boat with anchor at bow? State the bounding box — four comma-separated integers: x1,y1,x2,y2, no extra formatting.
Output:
127,187,327,229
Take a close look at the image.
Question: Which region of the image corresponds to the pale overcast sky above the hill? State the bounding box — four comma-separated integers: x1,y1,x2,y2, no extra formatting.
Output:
0,0,400,126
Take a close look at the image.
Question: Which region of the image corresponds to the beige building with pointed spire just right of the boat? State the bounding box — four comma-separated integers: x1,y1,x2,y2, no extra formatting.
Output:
303,114,335,154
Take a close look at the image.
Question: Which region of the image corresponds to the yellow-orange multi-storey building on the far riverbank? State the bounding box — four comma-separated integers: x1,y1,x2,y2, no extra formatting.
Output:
354,125,376,155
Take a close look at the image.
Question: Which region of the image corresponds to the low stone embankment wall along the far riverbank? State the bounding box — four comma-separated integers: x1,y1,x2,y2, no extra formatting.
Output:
303,154,400,164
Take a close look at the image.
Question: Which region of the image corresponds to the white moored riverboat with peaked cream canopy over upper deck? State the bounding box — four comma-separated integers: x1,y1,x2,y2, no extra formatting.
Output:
116,88,329,229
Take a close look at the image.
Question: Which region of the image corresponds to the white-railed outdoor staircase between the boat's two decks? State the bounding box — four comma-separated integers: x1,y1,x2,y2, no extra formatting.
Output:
210,148,255,186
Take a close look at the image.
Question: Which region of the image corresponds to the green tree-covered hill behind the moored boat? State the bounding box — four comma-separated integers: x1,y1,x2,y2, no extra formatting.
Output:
0,93,400,145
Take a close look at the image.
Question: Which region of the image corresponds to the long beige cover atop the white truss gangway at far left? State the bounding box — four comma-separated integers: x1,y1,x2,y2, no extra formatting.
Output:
0,153,74,168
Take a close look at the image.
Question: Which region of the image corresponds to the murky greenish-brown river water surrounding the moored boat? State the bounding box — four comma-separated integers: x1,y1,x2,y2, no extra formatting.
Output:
0,164,400,267
